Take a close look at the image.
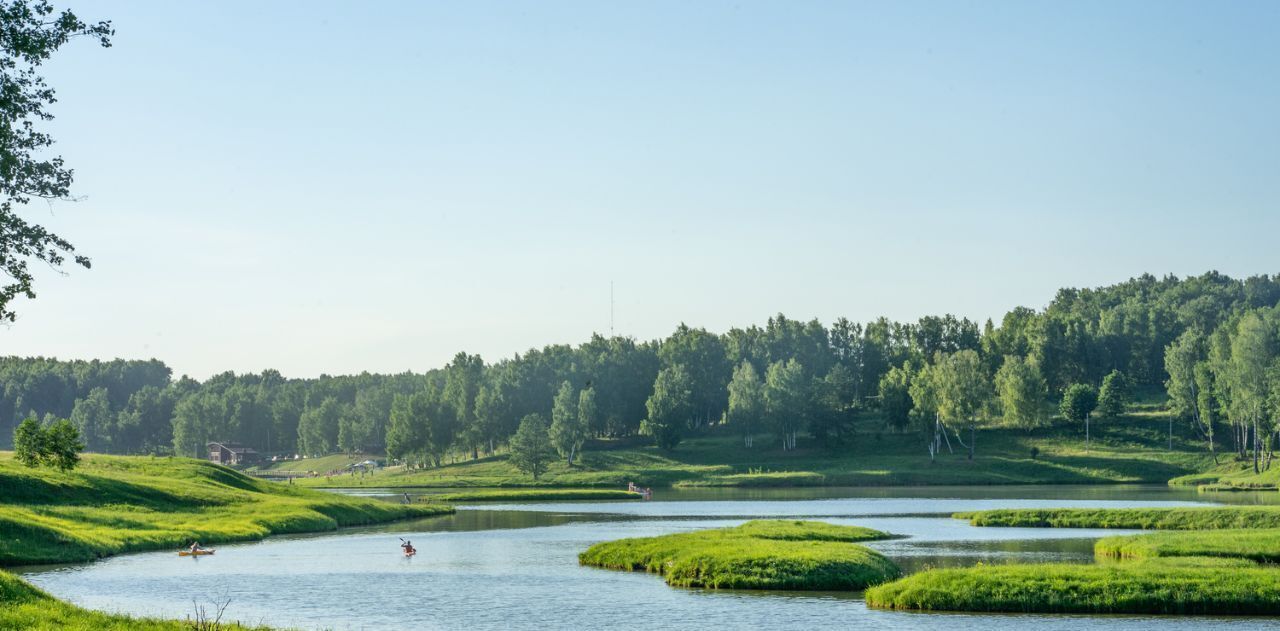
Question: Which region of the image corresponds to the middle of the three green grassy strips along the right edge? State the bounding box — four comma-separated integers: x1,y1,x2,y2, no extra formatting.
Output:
1093,530,1280,563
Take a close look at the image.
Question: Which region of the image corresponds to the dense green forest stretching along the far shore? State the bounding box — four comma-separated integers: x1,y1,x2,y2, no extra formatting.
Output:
0,273,1280,465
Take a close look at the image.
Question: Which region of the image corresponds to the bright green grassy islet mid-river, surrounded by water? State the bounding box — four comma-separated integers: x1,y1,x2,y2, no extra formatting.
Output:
579,521,900,590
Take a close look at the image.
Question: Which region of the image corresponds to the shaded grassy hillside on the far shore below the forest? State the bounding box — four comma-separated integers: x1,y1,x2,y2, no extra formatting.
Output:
298,408,1212,488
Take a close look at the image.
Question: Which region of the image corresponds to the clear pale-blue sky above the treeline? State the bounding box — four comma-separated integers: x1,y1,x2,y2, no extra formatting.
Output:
0,0,1280,378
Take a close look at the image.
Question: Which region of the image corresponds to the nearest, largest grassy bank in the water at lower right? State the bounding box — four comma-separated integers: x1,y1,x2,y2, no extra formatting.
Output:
867,559,1280,616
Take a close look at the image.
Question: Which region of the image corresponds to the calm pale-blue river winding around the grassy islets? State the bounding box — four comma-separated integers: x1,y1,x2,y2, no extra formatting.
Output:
19,486,1280,631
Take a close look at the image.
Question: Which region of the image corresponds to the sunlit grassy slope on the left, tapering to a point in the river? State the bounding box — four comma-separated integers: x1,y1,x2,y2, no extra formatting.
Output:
0,453,452,566
